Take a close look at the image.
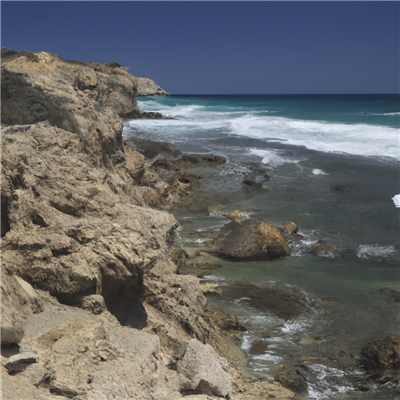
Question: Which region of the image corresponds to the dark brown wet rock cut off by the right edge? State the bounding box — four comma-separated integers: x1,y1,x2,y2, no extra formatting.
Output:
360,335,400,383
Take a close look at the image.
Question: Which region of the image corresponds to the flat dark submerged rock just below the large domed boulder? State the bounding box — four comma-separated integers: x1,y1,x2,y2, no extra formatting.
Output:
208,283,305,319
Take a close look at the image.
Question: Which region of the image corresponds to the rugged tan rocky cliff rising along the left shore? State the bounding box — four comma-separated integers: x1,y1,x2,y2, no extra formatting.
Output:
0,49,292,400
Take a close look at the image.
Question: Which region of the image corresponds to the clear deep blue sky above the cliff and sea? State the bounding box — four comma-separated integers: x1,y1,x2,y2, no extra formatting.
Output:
1,0,400,94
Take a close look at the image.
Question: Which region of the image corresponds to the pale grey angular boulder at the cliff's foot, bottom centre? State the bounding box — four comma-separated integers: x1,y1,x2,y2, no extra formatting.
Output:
176,339,232,397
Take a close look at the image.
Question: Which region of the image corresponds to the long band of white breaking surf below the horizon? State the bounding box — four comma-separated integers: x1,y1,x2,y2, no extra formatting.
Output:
128,99,400,159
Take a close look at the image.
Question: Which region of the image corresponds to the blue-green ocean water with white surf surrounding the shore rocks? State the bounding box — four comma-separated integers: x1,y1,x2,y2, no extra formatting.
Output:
124,95,400,399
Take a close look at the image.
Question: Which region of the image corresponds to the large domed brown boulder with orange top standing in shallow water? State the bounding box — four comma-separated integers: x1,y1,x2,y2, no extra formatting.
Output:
211,220,289,261
